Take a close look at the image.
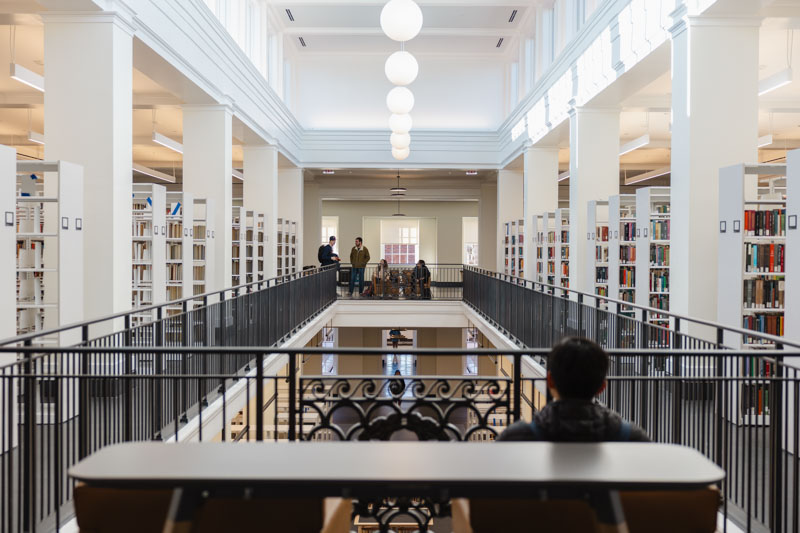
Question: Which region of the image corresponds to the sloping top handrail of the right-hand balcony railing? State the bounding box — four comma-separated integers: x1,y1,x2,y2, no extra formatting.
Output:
464,265,800,349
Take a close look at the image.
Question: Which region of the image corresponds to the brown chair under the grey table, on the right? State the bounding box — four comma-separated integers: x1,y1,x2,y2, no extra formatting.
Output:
452,488,720,533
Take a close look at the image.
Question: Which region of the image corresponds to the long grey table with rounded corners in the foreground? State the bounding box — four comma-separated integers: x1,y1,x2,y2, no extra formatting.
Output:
69,442,725,531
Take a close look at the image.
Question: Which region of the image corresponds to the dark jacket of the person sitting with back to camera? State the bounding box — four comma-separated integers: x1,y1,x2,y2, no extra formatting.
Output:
498,400,650,442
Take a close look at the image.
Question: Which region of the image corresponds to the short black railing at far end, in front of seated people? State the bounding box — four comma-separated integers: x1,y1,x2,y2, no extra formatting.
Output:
337,264,463,300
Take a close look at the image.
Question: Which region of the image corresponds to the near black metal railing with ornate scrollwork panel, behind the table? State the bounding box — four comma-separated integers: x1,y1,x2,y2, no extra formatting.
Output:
0,346,800,532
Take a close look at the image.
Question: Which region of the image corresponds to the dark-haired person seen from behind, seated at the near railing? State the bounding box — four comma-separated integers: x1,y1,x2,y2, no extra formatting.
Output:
498,337,650,442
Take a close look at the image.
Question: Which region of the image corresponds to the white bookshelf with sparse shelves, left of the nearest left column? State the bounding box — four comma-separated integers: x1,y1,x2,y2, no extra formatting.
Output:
15,161,84,345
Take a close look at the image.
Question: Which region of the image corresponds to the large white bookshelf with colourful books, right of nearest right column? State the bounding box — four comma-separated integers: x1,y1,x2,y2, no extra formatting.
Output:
717,164,796,425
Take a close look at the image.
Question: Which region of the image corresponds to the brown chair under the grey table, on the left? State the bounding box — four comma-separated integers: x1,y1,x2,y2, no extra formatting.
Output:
74,484,352,533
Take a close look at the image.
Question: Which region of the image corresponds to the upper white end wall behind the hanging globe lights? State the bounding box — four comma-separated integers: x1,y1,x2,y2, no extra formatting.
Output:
293,55,506,131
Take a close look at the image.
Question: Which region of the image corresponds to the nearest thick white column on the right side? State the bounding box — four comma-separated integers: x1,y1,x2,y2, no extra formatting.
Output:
670,11,758,326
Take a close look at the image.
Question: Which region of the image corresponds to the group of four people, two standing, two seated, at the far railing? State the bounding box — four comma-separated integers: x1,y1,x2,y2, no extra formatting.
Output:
317,236,431,298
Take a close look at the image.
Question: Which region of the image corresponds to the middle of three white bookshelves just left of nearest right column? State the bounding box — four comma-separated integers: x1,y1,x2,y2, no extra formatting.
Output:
608,194,636,317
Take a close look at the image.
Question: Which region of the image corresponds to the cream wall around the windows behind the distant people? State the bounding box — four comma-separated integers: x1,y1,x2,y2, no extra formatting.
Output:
322,200,478,264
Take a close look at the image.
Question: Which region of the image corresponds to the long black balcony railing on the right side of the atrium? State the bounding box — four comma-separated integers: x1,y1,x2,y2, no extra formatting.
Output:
463,266,800,350
